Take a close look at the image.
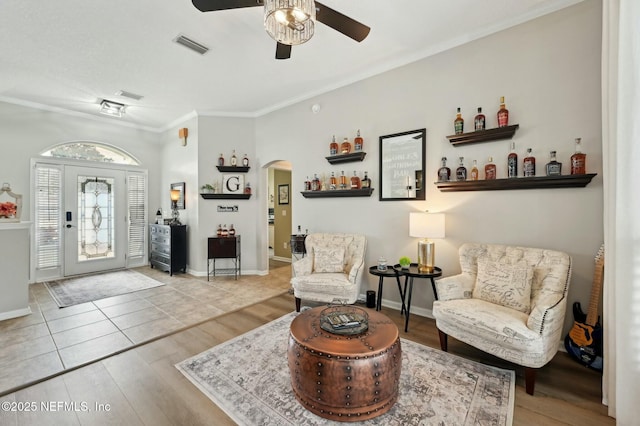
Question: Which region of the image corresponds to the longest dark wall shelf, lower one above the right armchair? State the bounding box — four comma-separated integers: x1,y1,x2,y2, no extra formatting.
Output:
435,173,597,192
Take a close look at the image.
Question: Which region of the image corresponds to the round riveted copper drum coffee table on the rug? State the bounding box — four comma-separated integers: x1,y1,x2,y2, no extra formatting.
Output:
287,307,402,422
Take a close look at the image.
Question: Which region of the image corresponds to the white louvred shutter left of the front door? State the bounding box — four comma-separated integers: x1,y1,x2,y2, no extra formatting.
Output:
35,164,62,269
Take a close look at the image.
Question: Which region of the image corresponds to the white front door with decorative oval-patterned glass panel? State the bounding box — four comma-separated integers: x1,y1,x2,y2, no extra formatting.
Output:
63,166,127,276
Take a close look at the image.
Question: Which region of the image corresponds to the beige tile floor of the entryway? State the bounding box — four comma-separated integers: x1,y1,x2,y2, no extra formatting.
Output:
0,262,290,395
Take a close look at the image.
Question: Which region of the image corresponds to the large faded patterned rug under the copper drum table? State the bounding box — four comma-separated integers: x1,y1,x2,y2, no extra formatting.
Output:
176,312,515,426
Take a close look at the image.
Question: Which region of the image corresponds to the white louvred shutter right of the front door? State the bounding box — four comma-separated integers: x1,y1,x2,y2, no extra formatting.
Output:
127,172,147,263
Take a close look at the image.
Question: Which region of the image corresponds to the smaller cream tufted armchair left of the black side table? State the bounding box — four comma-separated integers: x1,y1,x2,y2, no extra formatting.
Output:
291,233,367,312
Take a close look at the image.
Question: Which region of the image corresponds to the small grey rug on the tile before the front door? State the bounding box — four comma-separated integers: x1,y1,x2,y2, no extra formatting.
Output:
44,270,164,308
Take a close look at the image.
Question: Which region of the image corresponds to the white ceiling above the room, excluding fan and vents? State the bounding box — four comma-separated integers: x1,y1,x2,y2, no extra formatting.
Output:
0,0,581,131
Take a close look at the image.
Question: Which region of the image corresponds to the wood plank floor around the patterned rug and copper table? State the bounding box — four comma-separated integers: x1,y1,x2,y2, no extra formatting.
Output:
0,280,615,426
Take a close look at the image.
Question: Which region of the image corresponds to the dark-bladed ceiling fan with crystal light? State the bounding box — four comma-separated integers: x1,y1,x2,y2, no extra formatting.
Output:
191,0,371,59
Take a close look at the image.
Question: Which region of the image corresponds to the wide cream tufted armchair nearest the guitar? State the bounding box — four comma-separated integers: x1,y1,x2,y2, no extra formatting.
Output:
433,243,571,395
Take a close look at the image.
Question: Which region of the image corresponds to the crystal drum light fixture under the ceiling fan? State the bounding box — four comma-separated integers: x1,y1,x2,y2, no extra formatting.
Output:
264,0,316,46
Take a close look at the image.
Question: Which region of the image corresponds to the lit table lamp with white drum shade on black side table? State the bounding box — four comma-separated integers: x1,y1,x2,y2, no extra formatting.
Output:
409,212,444,273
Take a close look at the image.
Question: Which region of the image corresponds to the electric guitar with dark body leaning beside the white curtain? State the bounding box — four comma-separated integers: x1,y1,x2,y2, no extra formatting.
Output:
564,244,604,371
